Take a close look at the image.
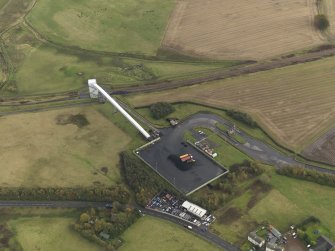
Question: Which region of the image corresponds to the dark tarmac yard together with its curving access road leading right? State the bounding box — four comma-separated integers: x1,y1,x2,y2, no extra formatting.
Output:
138,113,335,194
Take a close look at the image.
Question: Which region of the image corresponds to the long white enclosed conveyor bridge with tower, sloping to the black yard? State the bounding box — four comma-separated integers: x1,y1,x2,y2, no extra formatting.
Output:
88,79,151,139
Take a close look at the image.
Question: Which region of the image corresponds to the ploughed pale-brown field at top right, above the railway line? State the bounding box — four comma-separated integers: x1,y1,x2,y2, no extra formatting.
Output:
162,0,324,59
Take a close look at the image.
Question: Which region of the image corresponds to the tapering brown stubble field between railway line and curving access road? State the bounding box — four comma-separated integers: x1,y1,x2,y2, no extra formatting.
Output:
127,57,335,151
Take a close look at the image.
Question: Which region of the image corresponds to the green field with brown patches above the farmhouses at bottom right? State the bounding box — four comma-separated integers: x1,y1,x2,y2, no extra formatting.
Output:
213,171,335,244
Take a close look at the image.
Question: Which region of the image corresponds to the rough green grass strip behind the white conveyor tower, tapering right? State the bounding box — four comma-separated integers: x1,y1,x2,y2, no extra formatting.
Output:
16,46,231,94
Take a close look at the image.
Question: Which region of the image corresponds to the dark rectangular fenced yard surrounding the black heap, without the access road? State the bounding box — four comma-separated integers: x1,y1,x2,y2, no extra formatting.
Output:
136,125,228,194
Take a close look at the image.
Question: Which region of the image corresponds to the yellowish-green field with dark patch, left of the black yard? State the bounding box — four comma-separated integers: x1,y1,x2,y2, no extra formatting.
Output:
0,107,131,187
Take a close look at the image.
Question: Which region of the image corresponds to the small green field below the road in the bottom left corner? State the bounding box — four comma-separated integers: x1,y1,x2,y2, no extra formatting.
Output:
8,217,104,251
